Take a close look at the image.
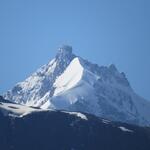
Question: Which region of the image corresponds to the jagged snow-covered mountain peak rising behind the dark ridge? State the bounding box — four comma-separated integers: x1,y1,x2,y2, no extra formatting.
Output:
4,46,150,126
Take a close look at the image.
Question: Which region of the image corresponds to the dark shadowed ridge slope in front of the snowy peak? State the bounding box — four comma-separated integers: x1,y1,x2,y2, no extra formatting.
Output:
0,111,150,150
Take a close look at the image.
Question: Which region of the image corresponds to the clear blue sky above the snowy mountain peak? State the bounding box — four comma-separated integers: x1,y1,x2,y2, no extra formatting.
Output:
0,0,150,100
